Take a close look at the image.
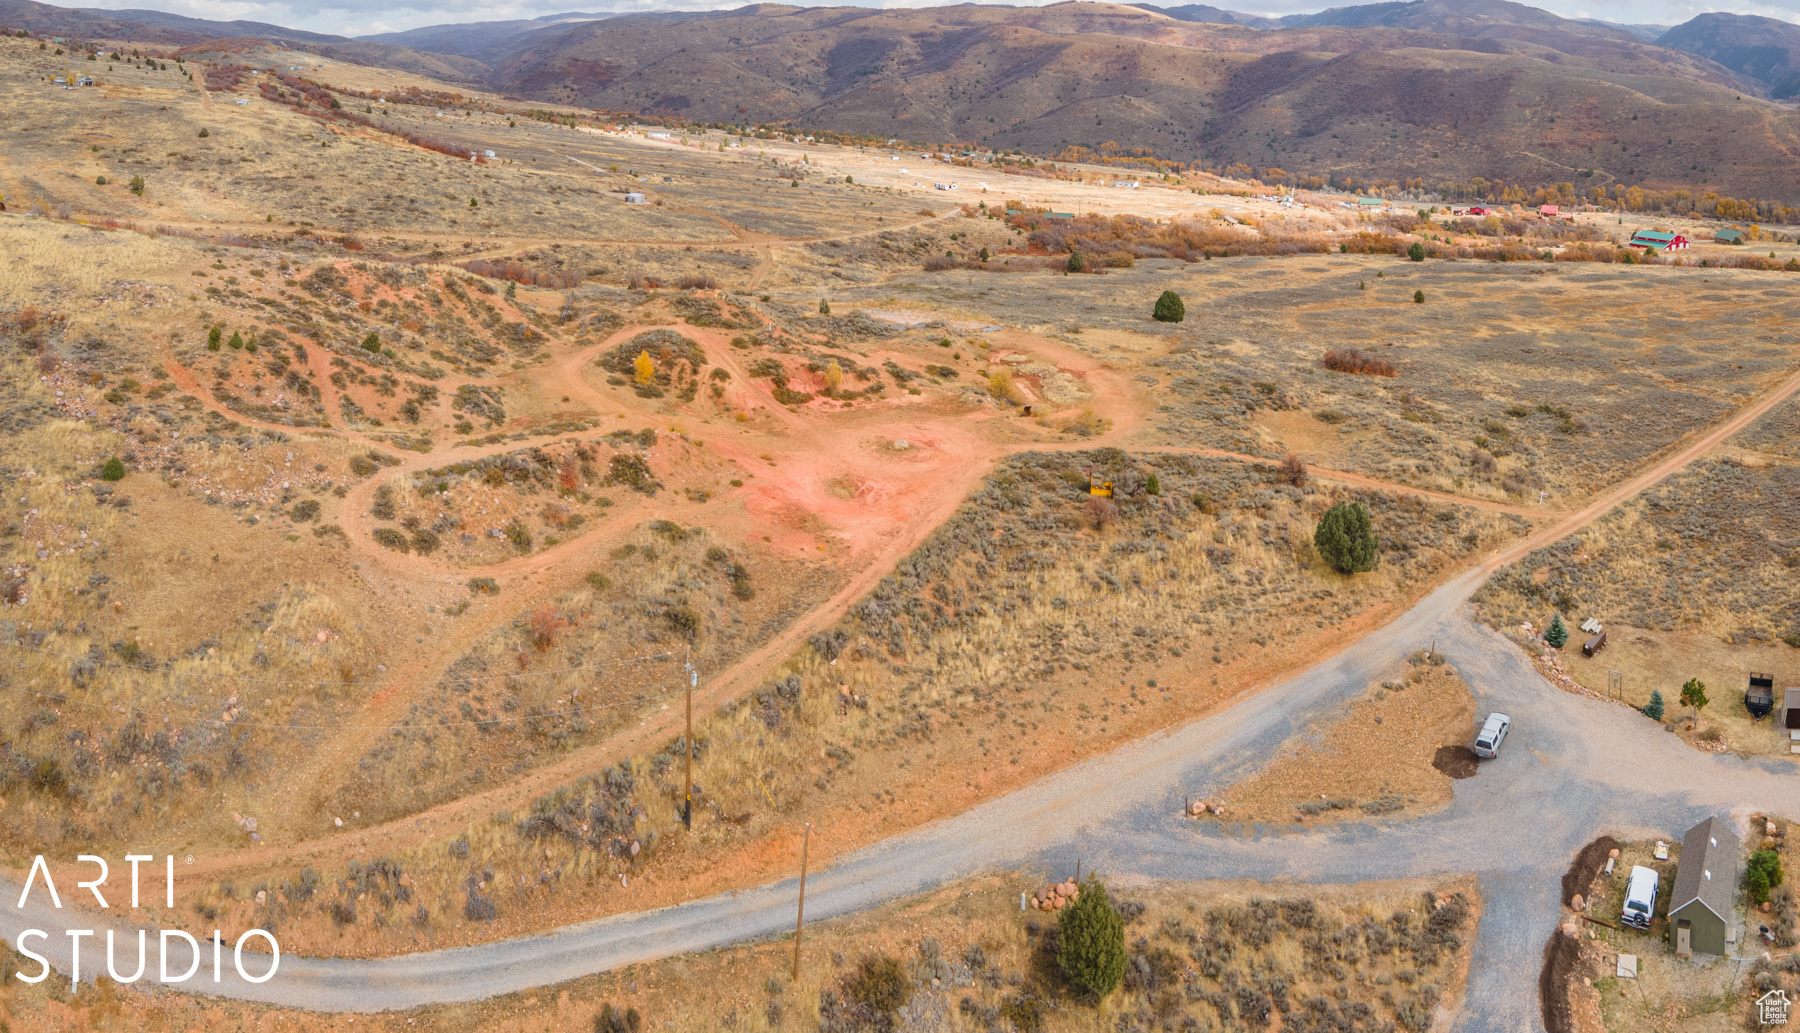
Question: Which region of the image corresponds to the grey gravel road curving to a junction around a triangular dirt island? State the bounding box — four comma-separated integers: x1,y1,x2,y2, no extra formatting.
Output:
0,572,1800,1033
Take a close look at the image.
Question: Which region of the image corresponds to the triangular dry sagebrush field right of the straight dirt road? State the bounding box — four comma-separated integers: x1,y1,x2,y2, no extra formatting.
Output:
1476,388,1800,756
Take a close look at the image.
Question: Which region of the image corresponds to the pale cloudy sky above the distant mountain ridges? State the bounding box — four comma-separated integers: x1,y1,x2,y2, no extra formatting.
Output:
70,0,1800,36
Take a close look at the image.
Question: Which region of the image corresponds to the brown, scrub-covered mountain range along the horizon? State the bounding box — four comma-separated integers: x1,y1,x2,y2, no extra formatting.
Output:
10,0,1800,198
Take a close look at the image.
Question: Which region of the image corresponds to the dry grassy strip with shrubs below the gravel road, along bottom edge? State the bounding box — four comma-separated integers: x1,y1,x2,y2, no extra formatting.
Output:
0,873,1481,1033
